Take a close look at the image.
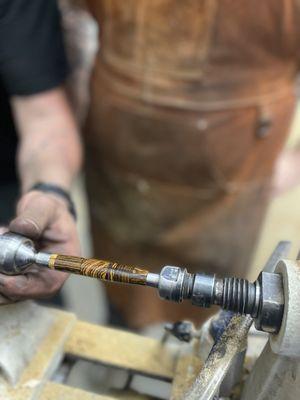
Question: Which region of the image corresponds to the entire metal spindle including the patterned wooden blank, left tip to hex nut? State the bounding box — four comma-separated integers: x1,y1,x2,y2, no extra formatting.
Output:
0,232,284,332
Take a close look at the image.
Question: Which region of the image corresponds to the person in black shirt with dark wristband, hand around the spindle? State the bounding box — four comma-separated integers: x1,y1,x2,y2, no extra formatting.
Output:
0,0,82,304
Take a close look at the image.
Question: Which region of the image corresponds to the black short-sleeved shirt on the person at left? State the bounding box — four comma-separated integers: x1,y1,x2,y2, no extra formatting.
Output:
0,0,67,185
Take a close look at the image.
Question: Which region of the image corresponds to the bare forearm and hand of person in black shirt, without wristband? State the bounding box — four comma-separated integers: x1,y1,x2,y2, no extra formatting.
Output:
0,88,81,303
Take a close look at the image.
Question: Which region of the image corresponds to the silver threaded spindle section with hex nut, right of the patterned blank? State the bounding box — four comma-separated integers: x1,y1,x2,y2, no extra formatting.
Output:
152,266,284,333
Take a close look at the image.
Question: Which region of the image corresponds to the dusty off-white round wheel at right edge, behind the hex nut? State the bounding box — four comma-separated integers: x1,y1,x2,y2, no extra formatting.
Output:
270,260,300,357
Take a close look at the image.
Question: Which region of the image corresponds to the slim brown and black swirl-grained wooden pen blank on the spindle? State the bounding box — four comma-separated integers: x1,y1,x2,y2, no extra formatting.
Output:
49,254,148,285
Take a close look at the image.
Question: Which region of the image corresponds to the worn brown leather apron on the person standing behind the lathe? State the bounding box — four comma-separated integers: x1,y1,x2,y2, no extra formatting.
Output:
85,0,296,327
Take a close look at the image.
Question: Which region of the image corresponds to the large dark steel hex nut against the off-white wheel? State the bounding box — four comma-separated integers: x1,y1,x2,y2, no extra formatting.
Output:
255,272,284,333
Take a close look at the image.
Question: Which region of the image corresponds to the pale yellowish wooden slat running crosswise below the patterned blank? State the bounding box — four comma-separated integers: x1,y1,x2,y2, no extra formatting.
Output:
64,321,176,382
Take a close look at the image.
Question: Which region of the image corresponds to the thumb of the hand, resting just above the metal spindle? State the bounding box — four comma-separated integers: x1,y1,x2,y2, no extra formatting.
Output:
9,191,56,239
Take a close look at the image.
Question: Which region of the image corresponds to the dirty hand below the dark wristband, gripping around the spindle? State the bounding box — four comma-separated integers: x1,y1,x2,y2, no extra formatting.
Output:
0,191,80,304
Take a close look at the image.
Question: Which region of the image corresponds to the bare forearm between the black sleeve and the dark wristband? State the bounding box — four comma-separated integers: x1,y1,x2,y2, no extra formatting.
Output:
11,88,81,193
